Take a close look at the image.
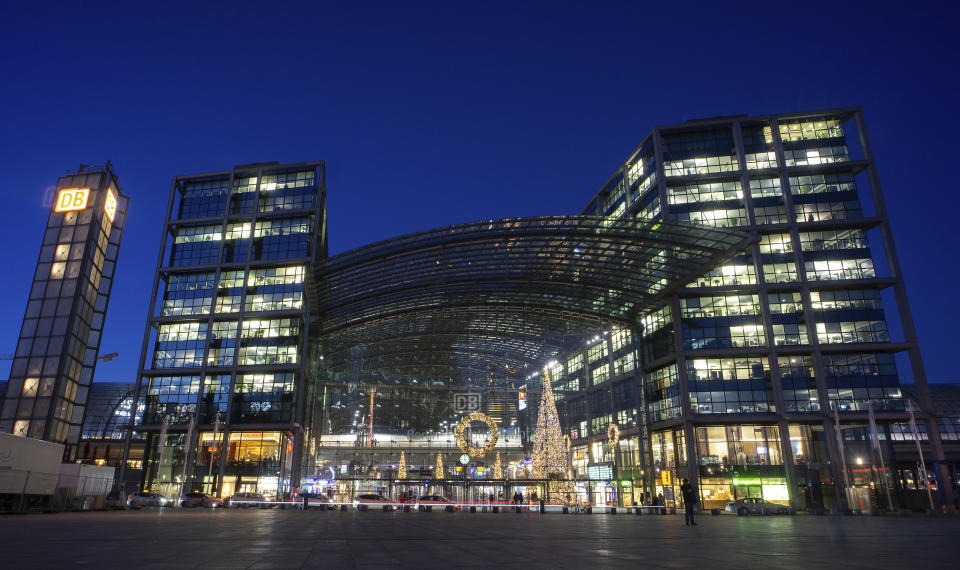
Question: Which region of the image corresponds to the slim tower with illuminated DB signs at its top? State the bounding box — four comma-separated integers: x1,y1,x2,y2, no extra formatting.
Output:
0,162,129,461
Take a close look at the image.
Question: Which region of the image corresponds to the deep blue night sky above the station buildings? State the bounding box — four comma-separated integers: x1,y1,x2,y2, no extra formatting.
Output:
0,0,960,382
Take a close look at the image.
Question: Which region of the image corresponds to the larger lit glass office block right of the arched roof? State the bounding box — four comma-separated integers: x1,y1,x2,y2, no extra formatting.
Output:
557,108,942,508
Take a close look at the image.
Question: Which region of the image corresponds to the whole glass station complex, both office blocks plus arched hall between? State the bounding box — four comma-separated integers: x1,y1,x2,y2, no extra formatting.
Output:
124,108,949,510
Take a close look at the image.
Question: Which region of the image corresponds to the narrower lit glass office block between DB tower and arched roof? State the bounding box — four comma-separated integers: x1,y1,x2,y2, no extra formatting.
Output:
127,162,327,495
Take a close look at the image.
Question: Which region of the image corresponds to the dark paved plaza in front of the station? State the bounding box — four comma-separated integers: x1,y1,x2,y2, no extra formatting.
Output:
0,509,960,569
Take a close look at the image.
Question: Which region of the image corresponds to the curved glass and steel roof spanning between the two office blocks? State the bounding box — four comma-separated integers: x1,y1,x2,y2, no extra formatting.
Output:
310,216,757,384
